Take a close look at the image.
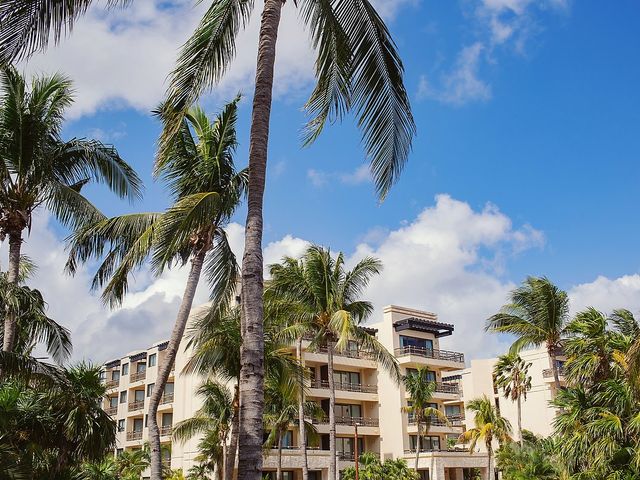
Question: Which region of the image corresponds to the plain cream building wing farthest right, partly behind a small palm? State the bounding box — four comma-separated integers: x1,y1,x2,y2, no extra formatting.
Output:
451,348,565,440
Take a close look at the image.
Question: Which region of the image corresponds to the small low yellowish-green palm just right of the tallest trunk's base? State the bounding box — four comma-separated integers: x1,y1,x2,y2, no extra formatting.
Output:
264,362,324,480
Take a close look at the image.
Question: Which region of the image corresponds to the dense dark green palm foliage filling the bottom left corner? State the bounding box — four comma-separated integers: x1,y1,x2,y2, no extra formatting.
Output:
0,364,116,479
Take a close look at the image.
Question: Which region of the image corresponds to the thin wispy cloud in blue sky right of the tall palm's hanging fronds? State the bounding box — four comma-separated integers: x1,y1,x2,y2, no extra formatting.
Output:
418,42,491,105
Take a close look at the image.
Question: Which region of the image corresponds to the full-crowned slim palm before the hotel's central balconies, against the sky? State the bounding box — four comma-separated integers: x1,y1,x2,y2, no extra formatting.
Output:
267,245,401,480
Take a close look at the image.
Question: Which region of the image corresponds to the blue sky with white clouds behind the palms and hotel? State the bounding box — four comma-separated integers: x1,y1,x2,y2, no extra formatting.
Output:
8,0,640,362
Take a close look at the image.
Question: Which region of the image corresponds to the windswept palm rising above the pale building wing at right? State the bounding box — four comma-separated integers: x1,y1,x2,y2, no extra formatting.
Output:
486,277,569,392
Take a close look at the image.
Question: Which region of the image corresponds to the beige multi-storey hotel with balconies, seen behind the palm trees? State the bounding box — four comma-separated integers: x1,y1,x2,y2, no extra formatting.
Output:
97,306,554,480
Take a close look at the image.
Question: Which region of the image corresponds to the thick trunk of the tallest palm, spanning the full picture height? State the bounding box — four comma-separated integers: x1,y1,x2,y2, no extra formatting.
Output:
238,0,283,480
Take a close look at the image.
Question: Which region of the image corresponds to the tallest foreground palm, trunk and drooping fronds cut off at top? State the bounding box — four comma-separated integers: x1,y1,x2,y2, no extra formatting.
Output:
0,0,415,480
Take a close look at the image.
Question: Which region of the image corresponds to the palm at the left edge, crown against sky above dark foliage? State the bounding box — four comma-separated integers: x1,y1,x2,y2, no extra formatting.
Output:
0,65,141,352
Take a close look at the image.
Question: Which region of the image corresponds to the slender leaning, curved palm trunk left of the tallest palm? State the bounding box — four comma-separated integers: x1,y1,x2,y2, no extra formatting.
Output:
147,250,206,480
